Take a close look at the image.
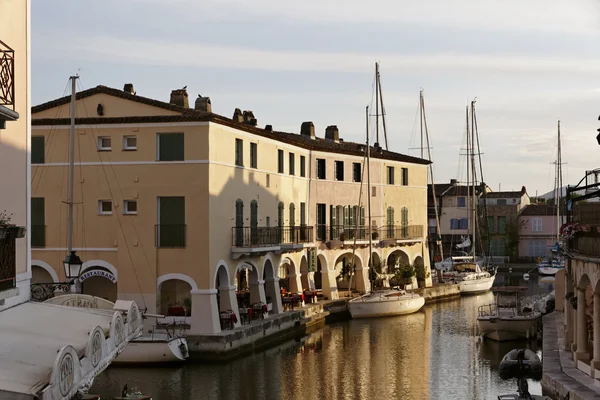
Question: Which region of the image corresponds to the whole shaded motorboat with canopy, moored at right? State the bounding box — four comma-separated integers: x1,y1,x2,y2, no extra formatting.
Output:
477,287,542,342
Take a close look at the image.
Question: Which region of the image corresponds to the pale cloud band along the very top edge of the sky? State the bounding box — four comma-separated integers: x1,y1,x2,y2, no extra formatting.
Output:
137,0,600,33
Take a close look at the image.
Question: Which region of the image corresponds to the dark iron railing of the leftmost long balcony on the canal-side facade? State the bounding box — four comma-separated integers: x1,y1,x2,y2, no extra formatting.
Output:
231,226,313,247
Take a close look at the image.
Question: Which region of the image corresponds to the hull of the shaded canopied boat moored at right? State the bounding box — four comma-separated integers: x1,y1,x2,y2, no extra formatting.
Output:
477,313,541,342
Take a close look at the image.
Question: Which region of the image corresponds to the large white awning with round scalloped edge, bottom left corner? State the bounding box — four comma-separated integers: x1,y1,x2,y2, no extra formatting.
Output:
0,302,142,400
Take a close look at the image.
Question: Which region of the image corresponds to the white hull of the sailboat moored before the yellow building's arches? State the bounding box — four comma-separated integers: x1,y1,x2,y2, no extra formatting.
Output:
348,290,425,318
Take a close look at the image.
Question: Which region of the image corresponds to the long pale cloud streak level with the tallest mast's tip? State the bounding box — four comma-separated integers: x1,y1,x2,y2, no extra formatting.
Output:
37,36,600,75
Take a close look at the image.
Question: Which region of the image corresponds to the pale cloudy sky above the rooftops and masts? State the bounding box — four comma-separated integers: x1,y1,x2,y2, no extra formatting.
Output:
32,0,600,196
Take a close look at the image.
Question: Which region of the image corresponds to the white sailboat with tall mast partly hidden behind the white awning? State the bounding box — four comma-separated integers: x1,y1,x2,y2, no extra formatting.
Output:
44,75,188,366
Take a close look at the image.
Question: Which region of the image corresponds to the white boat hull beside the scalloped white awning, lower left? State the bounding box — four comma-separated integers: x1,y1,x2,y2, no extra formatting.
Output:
112,336,188,365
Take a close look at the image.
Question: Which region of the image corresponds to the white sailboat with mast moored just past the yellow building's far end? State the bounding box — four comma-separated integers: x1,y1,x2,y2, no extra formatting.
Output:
444,101,498,294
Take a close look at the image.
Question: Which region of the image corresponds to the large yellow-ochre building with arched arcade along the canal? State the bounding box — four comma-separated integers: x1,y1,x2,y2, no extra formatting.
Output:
31,84,431,333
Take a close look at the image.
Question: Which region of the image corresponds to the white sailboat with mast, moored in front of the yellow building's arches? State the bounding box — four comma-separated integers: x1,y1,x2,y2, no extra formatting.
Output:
348,63,425,318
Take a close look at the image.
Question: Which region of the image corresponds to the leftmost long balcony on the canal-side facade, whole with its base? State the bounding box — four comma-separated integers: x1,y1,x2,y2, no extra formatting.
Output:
231,226,314,253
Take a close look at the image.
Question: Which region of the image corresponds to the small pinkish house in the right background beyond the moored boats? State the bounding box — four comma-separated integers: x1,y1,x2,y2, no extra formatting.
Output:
519,204,556,259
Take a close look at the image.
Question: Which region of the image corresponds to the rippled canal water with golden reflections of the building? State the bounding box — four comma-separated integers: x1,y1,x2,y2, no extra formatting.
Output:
90,272,552,400
